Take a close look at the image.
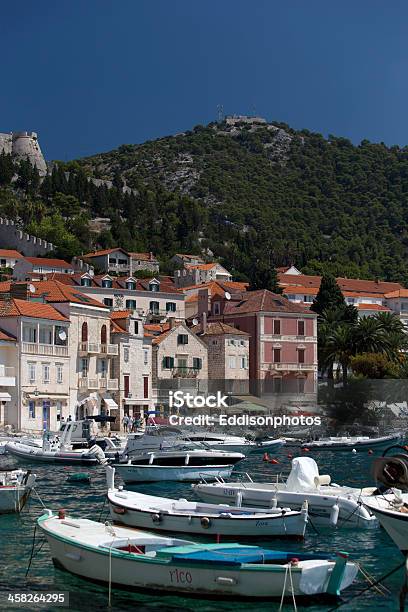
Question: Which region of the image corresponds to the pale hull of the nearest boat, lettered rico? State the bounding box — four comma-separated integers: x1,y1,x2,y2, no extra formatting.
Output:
39,518,358,599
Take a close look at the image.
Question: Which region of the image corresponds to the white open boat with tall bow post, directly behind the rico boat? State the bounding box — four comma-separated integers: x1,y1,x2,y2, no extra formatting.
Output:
106,466,307,538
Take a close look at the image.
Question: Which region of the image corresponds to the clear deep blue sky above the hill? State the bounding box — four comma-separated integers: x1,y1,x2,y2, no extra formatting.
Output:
0,0,408,159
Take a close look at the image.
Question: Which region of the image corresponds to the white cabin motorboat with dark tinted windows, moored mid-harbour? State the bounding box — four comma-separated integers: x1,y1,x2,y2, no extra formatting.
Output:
114,448,245,482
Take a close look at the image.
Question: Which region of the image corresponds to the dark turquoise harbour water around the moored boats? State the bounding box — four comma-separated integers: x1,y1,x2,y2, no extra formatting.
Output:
0,448,403,612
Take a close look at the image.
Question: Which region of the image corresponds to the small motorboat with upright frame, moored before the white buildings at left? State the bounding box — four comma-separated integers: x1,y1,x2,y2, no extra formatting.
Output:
6,421,106,465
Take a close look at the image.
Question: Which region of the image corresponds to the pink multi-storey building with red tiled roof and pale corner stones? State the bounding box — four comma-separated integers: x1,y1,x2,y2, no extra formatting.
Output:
207,289,317,394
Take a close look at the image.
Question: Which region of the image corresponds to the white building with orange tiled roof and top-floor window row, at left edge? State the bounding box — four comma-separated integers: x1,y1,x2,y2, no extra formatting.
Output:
0,291,70,432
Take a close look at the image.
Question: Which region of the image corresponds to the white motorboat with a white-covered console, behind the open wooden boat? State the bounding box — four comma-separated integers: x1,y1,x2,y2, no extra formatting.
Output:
193,457,378,529
